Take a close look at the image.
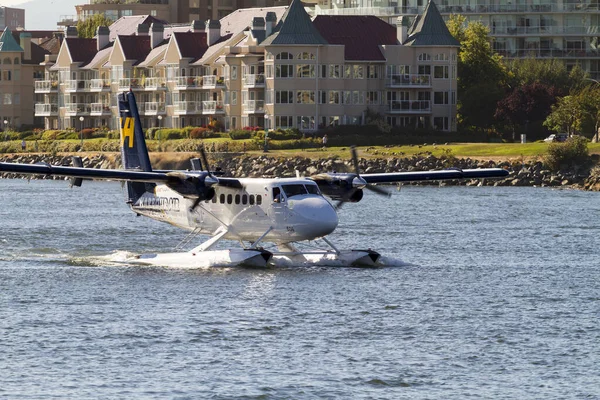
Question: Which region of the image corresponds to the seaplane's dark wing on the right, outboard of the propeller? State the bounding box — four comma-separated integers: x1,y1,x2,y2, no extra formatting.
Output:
360,168,508,183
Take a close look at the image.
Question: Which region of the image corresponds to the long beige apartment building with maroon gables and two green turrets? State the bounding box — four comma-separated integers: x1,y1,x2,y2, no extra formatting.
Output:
35,0,459,132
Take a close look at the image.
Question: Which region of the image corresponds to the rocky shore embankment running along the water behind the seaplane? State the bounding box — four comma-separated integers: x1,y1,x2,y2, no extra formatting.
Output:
0,153,600,191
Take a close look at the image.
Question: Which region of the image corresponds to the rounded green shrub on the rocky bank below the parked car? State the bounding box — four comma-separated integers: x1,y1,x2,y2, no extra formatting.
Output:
544,136,590,171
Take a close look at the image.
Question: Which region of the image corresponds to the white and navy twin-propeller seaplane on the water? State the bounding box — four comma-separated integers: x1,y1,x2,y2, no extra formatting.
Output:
0,91,508,267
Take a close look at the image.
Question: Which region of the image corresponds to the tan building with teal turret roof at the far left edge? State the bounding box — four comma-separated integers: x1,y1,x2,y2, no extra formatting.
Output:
0,28,58,129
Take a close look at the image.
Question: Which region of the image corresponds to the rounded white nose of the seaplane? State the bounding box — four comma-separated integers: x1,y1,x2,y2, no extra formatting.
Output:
292,197,338,237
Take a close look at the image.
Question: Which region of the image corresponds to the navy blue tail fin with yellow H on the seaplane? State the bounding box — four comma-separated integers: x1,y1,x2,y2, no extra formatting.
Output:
118,91,156,203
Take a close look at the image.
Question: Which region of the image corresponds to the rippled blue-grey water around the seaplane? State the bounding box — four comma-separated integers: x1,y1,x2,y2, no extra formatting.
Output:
0,180,600,399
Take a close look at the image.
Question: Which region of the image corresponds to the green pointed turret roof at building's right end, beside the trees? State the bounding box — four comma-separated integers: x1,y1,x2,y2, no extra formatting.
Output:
403,0,460,47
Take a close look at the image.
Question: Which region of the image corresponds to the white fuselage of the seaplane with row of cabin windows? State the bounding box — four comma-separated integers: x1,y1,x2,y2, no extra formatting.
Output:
131,178,338,243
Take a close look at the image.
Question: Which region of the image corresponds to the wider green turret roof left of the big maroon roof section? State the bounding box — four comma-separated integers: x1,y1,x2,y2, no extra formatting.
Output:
261,0,327,46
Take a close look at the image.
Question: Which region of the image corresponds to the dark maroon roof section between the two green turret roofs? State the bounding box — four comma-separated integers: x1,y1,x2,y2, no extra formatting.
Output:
313,15,398,61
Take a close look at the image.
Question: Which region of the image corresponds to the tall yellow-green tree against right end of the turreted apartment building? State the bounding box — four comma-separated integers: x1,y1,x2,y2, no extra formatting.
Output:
447,15,508,129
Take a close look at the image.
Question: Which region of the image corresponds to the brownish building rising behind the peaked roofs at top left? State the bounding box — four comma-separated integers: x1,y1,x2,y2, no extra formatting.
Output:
58,0,289,26
